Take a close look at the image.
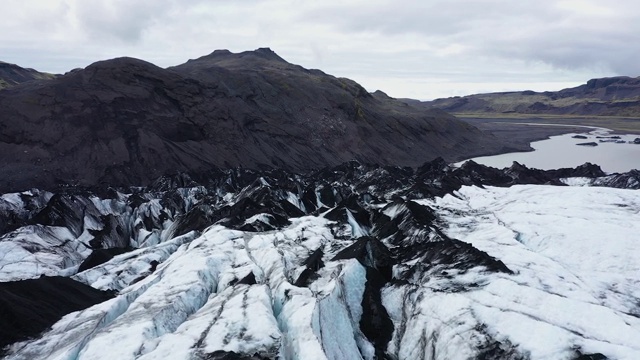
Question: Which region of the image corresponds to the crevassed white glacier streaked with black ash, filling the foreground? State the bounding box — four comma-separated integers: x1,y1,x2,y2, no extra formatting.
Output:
0,159,640,360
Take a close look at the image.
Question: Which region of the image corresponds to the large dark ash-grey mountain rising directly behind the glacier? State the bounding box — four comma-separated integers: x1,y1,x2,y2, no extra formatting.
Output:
0,49,508,191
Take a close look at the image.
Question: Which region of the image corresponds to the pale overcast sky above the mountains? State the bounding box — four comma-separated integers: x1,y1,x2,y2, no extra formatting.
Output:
0,0,640,100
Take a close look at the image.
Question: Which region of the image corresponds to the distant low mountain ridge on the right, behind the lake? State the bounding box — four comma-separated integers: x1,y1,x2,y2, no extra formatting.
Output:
418,76,640,117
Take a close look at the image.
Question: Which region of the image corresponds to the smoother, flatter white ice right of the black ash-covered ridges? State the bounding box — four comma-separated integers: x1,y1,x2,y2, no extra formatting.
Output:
404,185,640,359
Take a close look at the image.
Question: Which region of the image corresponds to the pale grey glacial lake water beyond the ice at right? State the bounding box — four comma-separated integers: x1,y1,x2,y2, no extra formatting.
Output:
456,128,640,173
